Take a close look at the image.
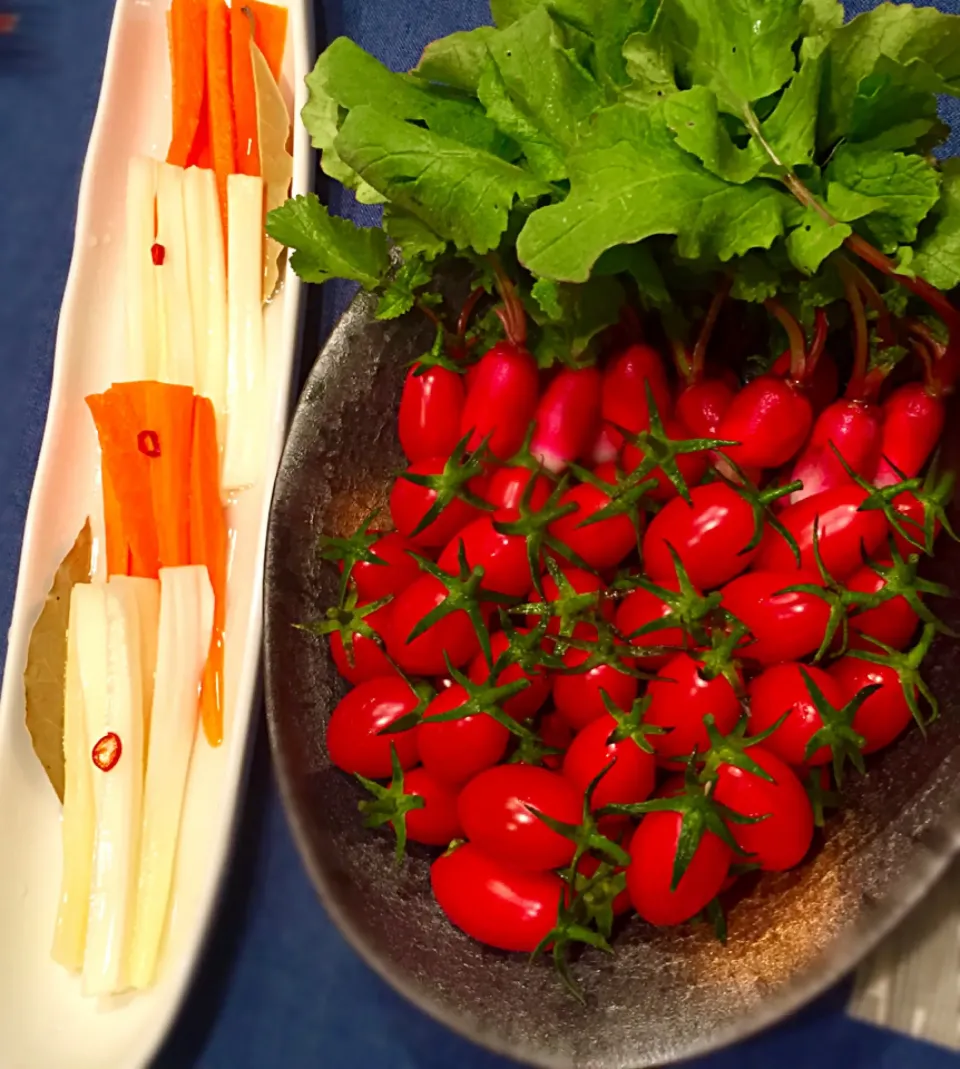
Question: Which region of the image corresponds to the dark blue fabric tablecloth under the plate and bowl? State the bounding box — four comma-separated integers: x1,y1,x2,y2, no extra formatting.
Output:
0,0,960,1069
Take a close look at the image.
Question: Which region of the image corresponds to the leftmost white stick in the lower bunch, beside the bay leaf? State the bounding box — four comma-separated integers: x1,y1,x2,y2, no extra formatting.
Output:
51,584,97,973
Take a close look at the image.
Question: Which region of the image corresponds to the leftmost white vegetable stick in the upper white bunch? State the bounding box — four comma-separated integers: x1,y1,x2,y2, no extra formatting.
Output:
124,156,160,382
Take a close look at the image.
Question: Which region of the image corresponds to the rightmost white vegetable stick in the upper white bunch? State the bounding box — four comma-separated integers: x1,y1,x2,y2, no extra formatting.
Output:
223,174,266,491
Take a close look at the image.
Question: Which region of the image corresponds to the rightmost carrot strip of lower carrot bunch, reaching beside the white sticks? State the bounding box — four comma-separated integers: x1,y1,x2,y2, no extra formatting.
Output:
190,397,227,746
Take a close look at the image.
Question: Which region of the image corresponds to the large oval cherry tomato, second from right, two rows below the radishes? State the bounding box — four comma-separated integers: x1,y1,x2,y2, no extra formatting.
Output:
721,571,830,665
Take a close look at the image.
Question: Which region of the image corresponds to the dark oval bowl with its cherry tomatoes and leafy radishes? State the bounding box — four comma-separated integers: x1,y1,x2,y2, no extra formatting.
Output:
266,0,960,1067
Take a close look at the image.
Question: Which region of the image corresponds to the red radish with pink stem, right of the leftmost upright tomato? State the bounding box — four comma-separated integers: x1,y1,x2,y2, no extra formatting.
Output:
460,341,540,460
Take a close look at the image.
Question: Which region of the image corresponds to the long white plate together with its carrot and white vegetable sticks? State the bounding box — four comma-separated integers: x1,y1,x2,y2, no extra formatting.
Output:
0,0,311,1069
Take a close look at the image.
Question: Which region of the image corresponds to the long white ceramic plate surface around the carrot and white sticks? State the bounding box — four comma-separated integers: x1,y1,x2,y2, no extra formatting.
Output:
0,0,311,1069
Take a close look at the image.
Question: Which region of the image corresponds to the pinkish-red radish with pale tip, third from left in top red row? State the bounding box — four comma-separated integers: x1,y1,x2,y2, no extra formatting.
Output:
530,368,601,475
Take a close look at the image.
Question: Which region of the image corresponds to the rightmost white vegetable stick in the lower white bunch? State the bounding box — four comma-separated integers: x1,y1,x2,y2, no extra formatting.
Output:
129,566,214,989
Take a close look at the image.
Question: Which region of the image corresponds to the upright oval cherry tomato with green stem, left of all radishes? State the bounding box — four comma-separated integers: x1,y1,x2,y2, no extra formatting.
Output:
398,365,466,462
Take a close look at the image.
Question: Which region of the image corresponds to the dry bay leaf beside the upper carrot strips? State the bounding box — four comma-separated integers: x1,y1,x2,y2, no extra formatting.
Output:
250,41,293,300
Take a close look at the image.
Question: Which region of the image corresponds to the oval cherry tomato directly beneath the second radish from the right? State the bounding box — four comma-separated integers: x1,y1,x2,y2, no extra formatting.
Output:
754,482,889,582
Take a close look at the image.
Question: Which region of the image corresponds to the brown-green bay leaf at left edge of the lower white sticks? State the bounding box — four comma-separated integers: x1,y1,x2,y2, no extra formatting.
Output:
24,520,93,802
